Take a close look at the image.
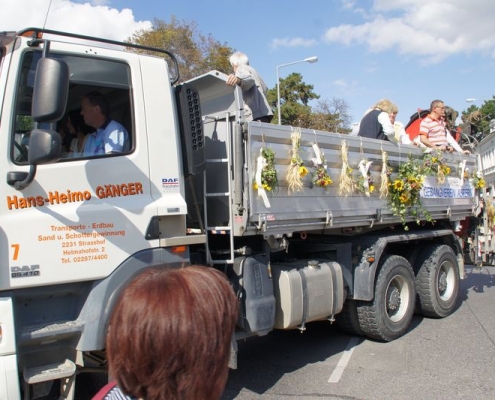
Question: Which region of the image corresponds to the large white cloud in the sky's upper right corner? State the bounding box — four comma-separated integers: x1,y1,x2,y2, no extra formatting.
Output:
323,0,495,63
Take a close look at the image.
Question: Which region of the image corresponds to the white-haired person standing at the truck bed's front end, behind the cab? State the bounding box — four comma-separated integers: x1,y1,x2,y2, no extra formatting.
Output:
227,51,273,123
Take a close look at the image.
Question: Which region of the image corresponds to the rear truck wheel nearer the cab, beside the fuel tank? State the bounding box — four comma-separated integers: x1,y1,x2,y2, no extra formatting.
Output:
357,255,416,342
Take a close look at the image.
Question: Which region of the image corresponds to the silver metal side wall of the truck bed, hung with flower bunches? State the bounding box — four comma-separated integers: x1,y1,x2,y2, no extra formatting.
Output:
246,123,476,236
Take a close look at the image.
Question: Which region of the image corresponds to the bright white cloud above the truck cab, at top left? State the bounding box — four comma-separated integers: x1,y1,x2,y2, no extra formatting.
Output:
0,0,152,40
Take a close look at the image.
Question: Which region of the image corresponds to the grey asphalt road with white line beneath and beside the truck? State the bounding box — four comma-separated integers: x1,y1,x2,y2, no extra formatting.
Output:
222,267,495,400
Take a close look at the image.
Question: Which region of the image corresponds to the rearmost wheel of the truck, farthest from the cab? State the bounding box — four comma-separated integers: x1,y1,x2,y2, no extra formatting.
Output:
415,244,459,318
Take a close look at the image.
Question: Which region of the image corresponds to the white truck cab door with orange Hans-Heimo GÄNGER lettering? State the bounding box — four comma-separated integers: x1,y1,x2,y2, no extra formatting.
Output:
0,44,157,290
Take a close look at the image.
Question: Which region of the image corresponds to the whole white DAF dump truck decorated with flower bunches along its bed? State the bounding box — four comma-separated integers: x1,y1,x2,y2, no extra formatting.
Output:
0,28,476,400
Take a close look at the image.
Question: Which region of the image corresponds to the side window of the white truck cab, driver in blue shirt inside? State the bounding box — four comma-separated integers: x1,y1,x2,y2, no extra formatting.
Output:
11,51,134,164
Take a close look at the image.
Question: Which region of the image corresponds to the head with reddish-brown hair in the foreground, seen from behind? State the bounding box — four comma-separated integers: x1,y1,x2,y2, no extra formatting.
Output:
107,266,237,400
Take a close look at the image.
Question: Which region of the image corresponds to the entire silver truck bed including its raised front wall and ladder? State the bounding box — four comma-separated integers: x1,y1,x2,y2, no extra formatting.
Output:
185,71,476,237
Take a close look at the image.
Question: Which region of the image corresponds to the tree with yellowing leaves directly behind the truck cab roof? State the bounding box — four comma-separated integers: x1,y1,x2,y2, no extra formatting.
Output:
126,16,234,82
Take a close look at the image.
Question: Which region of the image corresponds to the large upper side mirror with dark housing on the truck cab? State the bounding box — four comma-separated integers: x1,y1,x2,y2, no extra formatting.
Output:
31,57,69,122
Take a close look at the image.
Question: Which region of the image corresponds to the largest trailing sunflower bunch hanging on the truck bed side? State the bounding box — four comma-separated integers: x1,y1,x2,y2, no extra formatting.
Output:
388,155,432,231
